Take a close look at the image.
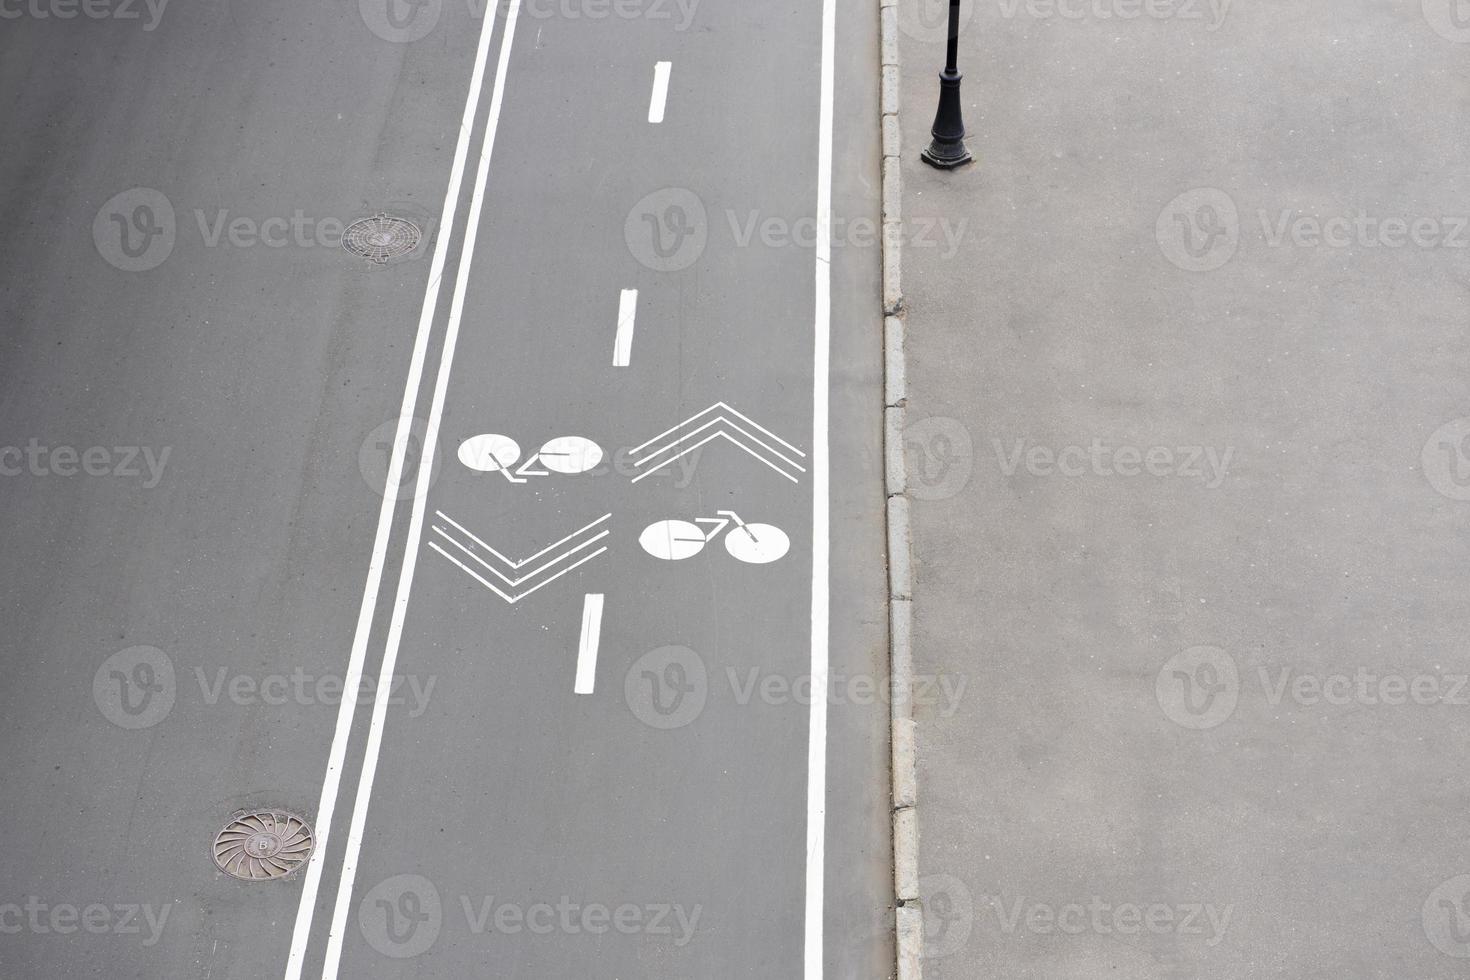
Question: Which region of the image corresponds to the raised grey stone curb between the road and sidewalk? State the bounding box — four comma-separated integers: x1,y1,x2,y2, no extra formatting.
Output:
878,0,923,980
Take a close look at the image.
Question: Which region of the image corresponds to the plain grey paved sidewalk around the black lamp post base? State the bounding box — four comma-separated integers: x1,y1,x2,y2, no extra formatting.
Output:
898,0,1470,980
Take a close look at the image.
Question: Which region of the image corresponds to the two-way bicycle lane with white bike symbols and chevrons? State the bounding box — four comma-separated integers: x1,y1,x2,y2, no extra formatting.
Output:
326,4,840,977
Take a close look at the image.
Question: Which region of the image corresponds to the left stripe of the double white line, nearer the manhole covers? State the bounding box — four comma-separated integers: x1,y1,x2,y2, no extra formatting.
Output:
285,3,505,980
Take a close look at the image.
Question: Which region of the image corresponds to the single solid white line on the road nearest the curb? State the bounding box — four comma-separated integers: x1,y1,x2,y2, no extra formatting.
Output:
806,0,836,980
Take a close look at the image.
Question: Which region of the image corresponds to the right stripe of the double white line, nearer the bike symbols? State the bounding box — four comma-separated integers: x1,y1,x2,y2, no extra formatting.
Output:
322,0,520,980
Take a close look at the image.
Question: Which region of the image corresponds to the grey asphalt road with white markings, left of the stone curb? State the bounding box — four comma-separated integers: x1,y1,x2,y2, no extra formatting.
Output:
0,0,892,980
